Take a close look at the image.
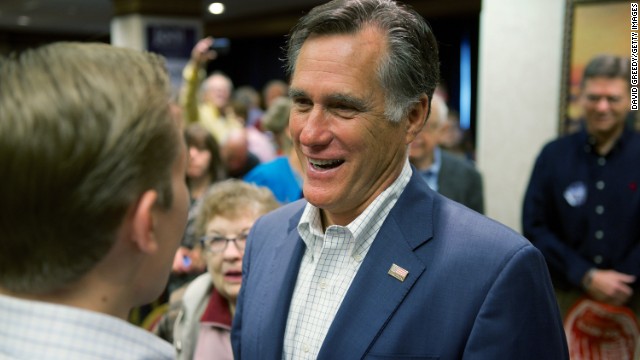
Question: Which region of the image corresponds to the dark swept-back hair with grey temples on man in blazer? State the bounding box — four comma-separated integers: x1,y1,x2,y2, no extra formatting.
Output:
287,0,440,122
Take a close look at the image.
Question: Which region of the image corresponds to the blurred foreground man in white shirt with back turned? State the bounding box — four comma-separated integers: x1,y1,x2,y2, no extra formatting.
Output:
0,43,188,359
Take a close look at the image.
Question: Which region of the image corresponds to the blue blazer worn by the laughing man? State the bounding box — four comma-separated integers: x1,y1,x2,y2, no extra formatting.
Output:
232,170,569,360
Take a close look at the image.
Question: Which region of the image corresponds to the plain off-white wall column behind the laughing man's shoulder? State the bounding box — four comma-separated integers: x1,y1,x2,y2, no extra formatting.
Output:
477,0,565,231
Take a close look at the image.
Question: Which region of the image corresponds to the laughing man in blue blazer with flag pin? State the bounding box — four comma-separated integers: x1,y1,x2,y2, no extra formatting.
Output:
232,0,568,360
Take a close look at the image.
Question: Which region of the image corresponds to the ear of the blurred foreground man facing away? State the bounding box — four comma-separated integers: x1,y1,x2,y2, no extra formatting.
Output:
132,190,158,254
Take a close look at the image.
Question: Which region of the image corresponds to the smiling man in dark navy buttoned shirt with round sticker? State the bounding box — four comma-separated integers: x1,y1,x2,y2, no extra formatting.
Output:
523,55,640,348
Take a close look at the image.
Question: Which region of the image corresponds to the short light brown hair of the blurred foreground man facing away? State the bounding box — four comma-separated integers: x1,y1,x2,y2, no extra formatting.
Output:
0,43,179,294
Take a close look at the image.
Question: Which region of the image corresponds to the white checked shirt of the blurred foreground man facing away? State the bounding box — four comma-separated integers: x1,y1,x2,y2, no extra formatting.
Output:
0,295,175,359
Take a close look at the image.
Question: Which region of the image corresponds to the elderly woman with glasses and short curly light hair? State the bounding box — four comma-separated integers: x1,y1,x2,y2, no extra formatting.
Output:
155,179,278,359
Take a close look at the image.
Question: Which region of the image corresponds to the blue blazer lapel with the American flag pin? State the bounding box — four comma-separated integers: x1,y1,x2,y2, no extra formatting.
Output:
318,171,433,359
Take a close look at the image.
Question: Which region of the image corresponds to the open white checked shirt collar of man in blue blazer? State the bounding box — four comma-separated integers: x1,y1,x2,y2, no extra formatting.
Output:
298,159,412,259
